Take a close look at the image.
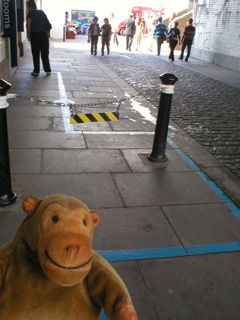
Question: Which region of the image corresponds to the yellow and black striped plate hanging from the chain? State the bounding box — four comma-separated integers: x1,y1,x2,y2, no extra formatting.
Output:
70,112,119,124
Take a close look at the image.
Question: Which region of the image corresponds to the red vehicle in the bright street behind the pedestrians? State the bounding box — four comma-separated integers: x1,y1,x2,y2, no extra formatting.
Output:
117,6,164,36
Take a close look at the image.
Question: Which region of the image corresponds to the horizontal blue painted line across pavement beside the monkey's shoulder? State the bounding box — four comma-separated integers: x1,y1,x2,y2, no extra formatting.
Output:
97,242,240,262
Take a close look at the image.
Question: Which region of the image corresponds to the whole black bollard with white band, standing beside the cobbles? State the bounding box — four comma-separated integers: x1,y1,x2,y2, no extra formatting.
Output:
148,73,178,163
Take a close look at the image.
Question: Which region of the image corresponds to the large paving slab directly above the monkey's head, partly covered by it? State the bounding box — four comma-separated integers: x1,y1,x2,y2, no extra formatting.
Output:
12,173,123,209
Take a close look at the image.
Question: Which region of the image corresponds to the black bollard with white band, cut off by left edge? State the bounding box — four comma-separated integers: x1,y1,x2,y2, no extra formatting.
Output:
0,80,17,206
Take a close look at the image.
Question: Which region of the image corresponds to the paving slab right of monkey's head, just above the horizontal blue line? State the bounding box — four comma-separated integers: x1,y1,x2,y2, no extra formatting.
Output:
93,207,181,250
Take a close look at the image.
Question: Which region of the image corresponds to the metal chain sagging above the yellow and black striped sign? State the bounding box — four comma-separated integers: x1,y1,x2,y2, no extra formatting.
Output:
16,93,141,115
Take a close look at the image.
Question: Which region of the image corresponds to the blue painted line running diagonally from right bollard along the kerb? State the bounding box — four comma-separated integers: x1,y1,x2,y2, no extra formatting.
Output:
167,138,240,220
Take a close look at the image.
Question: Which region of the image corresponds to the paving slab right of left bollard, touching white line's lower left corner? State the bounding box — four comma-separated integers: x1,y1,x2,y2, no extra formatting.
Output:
9,131,86,149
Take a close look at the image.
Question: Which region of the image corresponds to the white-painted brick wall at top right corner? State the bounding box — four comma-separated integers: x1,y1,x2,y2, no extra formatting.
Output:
191,0,240,71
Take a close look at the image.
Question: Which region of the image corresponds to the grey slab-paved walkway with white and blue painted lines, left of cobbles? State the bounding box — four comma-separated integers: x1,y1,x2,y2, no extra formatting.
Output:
0,36,240,320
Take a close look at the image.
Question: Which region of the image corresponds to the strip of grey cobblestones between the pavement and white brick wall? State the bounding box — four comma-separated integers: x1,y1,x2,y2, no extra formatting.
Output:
101,54,240,178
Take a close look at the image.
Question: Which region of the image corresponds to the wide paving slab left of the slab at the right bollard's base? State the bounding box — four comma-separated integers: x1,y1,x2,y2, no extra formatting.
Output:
43,149,130,173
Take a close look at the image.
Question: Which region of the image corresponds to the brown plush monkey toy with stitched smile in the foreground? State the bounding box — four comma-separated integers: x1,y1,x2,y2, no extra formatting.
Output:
0,194,137,320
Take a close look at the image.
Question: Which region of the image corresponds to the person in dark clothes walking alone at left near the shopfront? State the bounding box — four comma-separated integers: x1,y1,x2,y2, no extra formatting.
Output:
27,0,52,76
